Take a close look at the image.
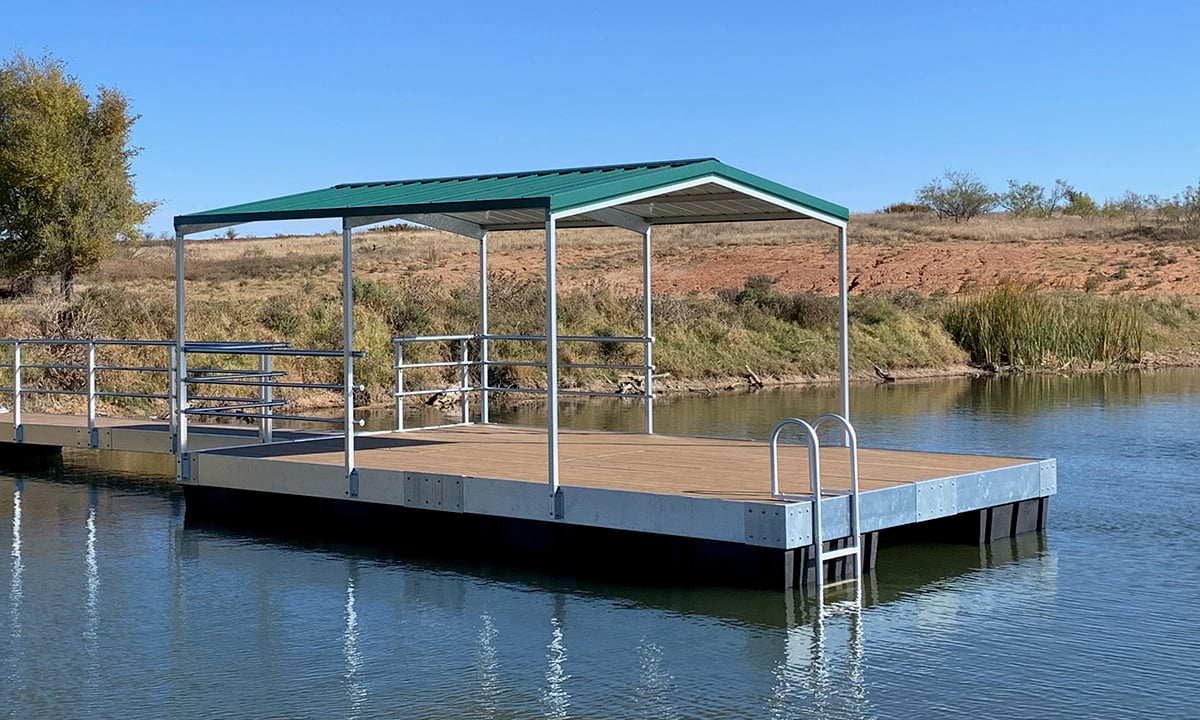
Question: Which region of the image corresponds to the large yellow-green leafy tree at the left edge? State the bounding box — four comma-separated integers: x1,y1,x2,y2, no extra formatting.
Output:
0,53,155,299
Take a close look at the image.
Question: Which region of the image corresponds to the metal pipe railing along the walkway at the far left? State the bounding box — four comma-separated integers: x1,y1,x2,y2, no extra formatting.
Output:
0,338,364,449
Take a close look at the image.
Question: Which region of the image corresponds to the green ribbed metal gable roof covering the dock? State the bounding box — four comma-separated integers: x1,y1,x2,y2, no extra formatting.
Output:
175,158,850,234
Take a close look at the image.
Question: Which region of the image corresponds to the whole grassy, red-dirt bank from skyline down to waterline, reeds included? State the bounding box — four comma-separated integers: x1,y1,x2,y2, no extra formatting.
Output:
0,214,1200,414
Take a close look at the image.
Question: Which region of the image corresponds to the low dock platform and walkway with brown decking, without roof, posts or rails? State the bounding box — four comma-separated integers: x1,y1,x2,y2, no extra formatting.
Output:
0,414,1056,588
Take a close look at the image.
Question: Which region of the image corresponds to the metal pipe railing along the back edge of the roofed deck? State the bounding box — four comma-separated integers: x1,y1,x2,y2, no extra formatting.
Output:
391,334,654,432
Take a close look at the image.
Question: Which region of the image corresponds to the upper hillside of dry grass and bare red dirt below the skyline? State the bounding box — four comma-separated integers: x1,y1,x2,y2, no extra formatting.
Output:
80,214,1200,296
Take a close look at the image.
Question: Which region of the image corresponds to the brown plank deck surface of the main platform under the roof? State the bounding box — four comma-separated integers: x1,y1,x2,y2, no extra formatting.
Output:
211,425,1033,500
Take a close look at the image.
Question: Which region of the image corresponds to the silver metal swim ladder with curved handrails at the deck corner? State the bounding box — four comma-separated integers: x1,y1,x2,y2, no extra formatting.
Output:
769,414,863,607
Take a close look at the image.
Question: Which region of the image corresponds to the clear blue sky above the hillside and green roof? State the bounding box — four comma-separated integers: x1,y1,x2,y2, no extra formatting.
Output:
0,0,1200,233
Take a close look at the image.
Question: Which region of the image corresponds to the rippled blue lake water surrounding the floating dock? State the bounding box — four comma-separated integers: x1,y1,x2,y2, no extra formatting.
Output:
0,371,1200,718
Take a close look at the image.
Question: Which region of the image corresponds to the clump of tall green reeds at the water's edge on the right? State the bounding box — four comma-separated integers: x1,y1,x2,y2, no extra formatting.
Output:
942,282,1146,367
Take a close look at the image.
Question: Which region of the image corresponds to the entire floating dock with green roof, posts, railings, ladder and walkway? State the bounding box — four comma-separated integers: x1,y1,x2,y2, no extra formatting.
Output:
0,158,1056,592
